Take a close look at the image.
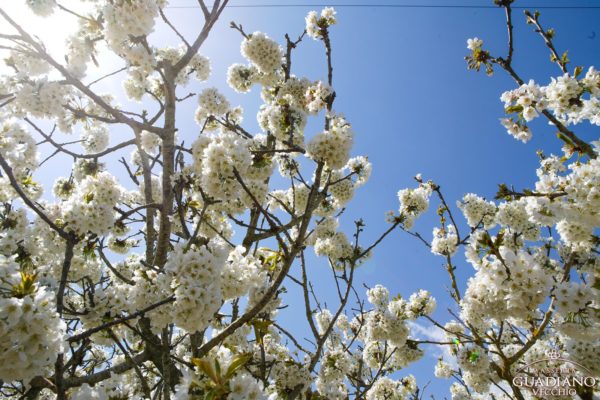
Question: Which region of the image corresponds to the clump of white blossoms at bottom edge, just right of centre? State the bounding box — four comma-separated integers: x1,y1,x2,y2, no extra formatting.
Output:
316,285,435,399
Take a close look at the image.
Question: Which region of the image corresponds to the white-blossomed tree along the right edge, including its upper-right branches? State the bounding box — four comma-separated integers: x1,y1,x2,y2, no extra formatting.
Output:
427,0,600,399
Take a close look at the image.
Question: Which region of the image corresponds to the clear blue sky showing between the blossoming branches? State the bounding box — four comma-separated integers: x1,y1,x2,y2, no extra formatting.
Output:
0,0,600,398
